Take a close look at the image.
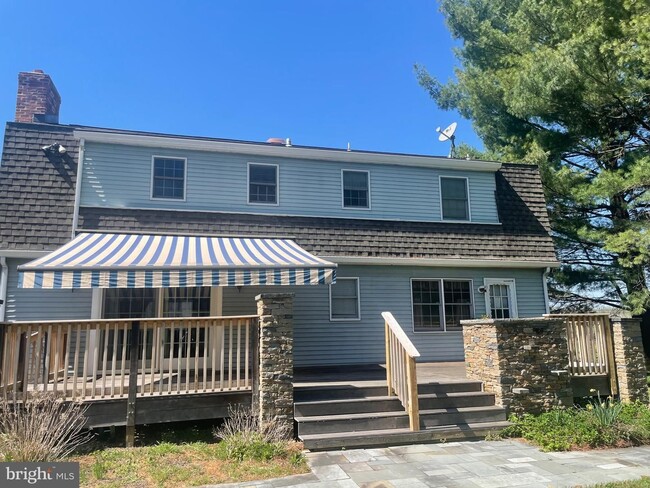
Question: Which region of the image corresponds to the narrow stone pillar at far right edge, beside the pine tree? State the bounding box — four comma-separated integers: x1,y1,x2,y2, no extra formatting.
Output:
611,317,648,403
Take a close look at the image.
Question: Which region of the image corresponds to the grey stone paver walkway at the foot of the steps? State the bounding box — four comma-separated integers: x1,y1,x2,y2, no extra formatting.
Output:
215,440,650,488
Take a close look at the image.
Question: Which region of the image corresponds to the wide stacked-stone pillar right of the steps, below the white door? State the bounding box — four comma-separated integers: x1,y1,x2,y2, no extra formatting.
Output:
461,317,573,413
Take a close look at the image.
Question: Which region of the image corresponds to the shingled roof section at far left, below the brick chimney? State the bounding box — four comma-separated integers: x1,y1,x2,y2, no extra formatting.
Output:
0,122,79,250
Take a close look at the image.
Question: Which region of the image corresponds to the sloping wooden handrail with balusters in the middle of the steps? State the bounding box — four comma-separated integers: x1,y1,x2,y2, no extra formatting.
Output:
381,312,420,431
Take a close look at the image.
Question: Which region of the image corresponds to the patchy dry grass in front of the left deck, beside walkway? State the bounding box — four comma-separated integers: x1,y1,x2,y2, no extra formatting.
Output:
71,442,309,488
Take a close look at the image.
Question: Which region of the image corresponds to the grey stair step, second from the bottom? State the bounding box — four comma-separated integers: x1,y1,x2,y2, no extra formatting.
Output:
296,406,506,436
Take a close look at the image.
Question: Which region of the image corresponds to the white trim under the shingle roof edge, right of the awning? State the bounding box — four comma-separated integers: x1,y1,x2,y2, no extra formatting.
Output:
319,255,560,269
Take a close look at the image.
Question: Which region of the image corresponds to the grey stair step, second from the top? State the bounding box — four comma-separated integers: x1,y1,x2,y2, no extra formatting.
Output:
294,391,494,417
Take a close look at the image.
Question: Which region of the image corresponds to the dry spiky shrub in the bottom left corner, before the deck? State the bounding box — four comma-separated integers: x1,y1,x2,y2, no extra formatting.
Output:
0,393,92,462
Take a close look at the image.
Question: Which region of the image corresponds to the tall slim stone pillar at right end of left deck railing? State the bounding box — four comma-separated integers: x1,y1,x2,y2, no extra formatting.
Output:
255,293,294,432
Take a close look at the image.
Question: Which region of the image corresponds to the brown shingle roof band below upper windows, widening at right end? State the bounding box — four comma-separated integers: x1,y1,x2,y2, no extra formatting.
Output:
74,164,555,261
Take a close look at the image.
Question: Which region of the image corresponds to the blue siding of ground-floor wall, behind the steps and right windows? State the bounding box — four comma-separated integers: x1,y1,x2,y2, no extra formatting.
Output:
223,266,546,366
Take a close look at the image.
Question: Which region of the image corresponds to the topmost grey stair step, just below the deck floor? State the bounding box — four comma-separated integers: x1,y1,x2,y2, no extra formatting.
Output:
294,380,483,402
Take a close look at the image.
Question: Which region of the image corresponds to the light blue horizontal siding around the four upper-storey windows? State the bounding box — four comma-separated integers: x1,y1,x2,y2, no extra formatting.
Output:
81,143,498,223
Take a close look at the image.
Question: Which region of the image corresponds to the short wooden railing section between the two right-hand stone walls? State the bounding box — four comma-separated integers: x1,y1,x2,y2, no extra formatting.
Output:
545,313,618,394
